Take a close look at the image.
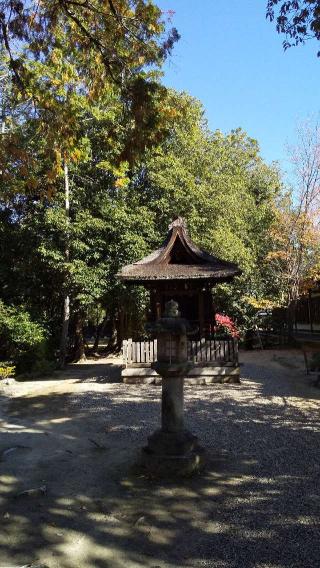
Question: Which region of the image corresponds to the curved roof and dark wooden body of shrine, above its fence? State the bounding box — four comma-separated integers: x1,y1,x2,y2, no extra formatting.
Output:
119,217,241,336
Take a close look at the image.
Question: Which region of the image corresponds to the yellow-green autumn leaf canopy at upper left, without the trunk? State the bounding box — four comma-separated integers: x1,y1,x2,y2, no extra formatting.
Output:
0,0,179,186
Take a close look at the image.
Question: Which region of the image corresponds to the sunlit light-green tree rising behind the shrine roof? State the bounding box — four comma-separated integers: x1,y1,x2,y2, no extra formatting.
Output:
128,95,281,324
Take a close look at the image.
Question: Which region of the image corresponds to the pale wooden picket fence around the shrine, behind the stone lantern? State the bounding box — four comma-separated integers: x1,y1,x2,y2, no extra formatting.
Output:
122,337,238,366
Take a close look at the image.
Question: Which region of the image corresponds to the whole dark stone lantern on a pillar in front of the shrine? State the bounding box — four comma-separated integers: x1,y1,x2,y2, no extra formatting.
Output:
142,300,204,476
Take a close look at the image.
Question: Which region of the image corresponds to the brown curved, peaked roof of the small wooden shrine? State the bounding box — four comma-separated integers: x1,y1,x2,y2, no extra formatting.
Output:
118,217,241,283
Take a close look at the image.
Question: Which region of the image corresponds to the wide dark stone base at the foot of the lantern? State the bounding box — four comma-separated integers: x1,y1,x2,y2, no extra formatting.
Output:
141,430,205,478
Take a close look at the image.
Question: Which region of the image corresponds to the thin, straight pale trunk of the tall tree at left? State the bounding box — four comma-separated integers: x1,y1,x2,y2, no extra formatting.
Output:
59,162,70,367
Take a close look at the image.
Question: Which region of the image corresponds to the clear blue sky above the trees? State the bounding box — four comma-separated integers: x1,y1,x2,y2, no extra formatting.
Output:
157,0,320,171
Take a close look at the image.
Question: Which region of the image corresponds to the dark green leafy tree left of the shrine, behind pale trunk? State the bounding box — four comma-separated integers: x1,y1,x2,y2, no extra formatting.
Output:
0,107,160,359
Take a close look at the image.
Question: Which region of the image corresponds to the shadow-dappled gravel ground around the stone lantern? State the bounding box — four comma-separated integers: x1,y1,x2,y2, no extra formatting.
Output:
0,351,320,568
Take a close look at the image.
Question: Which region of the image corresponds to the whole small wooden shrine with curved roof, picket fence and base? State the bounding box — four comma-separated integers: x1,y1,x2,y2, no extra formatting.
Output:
118,217,241,384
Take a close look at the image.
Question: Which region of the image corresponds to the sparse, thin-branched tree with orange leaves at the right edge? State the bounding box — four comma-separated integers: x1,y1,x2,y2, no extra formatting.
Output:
268,120,320,304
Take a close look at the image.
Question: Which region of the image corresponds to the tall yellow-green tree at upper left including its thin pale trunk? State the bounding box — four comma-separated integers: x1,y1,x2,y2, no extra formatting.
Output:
0,0,179,362
